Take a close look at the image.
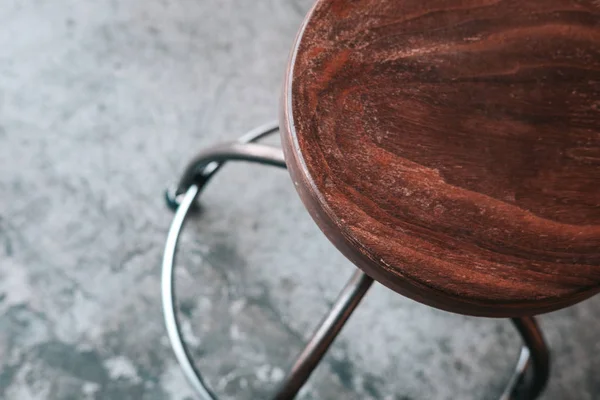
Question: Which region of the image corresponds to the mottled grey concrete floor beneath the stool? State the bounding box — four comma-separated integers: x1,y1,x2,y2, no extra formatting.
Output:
0,0,600,400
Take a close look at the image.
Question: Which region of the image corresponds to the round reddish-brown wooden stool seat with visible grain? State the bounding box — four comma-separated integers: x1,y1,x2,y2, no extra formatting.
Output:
281,0,600,317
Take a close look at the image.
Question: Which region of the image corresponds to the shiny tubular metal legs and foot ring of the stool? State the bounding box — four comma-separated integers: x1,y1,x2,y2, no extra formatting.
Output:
161,122,550,400
